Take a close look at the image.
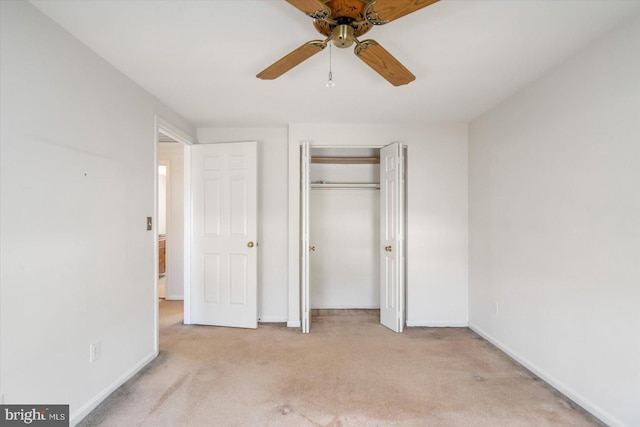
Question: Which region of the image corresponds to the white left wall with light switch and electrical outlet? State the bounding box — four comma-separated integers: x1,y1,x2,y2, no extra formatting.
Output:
0,1,193,425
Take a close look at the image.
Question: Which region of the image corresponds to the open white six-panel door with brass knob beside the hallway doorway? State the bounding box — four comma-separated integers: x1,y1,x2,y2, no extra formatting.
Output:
190,142,258,328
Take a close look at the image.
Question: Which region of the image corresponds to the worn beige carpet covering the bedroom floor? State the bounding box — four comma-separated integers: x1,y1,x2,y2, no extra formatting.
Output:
80,301,601,427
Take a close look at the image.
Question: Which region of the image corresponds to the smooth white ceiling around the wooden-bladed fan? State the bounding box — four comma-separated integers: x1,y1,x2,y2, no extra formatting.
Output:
32,0,640,127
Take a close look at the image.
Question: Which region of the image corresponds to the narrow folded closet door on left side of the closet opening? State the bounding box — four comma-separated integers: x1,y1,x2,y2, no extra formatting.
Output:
300,142,311,334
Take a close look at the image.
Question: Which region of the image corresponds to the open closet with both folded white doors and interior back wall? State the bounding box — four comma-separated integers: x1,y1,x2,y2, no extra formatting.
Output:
301,143,405,333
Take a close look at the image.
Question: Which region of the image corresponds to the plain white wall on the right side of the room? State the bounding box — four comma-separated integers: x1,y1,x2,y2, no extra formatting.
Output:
469,18,640,426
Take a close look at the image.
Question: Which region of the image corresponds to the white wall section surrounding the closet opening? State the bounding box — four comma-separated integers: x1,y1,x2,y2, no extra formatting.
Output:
288,124,468,326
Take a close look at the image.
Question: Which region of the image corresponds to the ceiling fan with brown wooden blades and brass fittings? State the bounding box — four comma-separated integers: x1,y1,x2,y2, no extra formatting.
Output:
256,0,439,86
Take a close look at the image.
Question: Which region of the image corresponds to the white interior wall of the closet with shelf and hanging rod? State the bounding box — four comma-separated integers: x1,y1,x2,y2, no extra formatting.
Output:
310,148,380,309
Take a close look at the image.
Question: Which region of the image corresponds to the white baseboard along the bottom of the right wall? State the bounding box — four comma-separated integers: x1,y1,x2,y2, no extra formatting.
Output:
469,322,626,427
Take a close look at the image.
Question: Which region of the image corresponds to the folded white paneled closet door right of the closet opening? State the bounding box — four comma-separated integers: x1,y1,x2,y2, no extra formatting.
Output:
380,143,404,332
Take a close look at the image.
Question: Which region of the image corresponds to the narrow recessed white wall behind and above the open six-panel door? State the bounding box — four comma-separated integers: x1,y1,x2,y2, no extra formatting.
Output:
198,128,287,322
